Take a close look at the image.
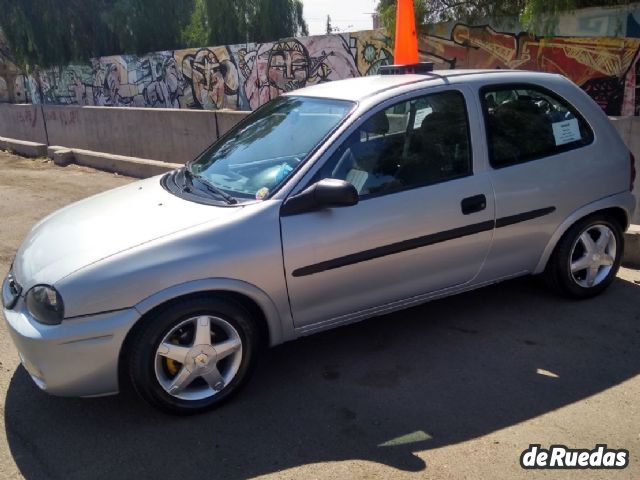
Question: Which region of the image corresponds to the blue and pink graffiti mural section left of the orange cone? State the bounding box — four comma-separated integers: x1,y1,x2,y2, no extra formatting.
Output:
25,31,392,110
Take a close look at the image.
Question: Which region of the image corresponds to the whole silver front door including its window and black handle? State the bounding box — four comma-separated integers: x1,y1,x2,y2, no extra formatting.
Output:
281,89,494,328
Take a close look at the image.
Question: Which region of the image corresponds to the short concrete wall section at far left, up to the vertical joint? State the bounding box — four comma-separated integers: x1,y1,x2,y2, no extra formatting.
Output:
0,104,47,144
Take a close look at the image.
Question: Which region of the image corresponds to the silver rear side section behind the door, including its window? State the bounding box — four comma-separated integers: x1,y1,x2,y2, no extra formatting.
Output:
478,80,611,280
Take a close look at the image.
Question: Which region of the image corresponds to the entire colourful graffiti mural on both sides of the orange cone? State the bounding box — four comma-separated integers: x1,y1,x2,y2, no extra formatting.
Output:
13,24,640,115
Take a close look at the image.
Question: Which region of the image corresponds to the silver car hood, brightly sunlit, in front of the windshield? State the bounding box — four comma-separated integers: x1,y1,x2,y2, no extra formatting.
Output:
13,177,242,290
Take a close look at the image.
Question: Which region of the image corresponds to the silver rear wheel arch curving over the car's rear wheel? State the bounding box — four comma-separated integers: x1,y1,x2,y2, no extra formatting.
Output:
533,194,635,274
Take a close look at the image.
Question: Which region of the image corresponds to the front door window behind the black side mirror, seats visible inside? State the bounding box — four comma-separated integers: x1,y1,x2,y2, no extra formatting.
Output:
318,91,472,198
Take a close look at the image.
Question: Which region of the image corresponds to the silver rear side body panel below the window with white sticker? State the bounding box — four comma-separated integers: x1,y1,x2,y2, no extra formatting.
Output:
482,144,610,279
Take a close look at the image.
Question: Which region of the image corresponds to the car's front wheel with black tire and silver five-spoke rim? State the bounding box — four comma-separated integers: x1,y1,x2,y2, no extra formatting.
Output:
126,297,260,415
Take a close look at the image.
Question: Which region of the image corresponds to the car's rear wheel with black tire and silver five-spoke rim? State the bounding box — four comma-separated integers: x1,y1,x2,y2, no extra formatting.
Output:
544,215,624,299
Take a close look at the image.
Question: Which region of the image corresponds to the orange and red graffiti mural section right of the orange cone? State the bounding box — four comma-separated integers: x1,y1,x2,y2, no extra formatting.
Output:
420,24,640,115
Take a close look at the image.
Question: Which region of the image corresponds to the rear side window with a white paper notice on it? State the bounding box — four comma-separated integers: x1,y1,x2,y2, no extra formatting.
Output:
481,85,593,168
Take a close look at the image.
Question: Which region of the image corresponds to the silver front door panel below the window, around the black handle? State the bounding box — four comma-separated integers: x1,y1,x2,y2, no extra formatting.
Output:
281,174,495,328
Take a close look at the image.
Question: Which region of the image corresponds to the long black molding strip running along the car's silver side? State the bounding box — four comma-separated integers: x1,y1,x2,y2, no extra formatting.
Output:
292,207,556,277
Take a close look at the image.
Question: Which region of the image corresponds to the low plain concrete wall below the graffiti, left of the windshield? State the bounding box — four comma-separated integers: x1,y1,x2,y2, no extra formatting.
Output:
11,105,248,163
